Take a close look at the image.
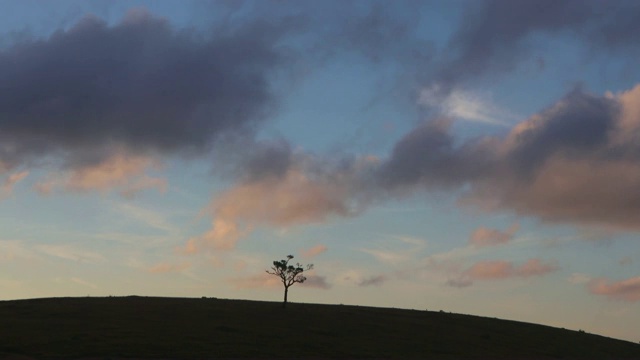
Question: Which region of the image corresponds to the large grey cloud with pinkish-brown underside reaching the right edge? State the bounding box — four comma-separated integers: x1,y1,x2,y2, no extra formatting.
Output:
376,85,640,231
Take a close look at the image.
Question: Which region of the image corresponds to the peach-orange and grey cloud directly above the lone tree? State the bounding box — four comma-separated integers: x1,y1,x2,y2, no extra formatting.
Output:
187,154,375,253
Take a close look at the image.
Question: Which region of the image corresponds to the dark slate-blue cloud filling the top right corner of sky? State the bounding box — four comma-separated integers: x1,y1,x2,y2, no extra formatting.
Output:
437,0,640,85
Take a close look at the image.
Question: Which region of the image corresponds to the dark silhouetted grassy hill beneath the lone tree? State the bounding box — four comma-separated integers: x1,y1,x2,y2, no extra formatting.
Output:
0,296,640,359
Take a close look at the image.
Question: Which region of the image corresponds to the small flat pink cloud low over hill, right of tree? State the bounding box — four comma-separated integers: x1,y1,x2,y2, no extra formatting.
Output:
446,258,559,288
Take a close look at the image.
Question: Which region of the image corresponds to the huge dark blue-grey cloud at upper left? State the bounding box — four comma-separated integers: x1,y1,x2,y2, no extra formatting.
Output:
0,10,286,169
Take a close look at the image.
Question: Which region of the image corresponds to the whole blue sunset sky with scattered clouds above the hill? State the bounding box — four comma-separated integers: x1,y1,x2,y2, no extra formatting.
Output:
0,0,640,342
